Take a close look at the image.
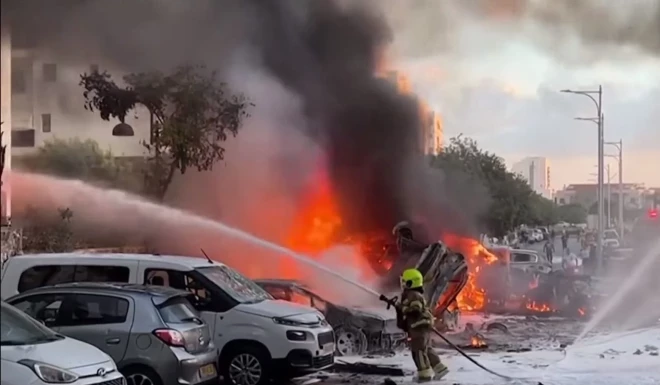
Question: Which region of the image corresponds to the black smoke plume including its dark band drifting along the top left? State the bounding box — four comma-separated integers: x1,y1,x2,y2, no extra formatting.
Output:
2,0,483,238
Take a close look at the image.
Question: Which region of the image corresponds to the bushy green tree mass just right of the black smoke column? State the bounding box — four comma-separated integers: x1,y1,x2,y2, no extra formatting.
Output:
431,136,555,237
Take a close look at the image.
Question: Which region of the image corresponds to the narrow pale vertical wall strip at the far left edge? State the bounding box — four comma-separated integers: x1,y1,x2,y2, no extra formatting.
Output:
0,23,12,223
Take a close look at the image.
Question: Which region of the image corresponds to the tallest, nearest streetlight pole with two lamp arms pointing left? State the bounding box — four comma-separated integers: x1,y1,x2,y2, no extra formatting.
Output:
560,86,605,273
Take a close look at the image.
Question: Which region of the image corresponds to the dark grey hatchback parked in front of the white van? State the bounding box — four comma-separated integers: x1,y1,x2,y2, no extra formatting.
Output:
7,283,218,385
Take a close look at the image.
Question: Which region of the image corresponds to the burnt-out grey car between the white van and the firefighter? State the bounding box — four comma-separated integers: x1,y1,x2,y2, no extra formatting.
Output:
255,279,406,356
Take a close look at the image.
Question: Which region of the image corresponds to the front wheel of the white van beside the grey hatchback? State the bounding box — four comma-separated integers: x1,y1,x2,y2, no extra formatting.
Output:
220,346,270,385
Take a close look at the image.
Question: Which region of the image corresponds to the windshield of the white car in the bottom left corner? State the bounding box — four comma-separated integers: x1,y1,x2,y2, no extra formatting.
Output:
0,302,63,346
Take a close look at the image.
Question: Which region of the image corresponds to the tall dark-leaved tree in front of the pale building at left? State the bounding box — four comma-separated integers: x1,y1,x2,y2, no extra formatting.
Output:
80,66,252,199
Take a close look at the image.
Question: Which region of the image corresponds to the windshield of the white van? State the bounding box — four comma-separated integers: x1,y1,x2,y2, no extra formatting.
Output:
195,265,273,303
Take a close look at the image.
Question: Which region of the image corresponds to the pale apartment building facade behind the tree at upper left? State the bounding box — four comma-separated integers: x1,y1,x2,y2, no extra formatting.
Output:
11,50,149,156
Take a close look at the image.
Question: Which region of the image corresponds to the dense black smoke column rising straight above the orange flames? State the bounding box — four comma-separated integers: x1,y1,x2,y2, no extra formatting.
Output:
245,0,421,232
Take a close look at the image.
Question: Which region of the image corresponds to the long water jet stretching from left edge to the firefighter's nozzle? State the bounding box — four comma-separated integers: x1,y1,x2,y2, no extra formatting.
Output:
10,172,379,302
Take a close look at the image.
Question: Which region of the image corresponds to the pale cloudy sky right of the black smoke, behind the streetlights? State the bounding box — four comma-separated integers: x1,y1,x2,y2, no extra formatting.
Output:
388,0,660,188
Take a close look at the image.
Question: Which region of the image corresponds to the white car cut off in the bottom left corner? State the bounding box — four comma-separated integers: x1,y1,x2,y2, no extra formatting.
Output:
0,301,126,385
